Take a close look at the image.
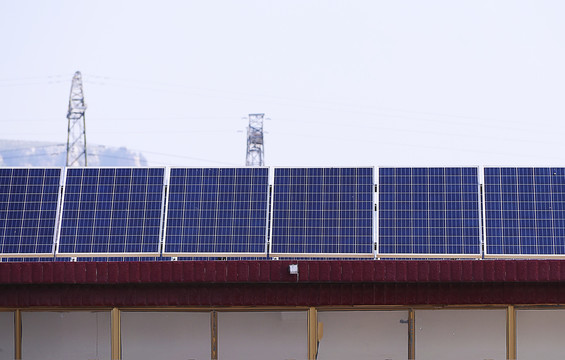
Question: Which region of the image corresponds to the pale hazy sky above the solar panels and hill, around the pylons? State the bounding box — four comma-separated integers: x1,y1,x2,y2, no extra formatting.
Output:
0,0,565,166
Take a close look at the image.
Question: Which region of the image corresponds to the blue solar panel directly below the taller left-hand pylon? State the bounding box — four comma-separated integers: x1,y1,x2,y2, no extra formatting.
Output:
58,168,165,256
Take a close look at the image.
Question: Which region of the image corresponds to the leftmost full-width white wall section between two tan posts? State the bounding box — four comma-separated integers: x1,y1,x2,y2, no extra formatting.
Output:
22,311,110,360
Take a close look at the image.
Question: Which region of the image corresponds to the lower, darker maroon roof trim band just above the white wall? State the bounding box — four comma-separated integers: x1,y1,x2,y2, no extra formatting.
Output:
0,283,565,308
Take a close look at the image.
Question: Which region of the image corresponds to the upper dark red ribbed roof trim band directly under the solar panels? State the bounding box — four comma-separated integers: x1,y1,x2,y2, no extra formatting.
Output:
0,260,565,285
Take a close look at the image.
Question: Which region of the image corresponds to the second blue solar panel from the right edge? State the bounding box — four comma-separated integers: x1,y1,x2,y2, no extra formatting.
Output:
379,168,481,256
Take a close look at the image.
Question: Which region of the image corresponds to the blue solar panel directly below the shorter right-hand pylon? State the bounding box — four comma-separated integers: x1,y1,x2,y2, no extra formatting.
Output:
164,168,269,254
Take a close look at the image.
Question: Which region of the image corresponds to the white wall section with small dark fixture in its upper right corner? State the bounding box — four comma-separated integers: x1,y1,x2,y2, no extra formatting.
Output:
318,311,408,360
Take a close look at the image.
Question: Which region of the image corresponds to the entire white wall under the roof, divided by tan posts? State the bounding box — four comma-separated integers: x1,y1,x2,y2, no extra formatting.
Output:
16,309,565,360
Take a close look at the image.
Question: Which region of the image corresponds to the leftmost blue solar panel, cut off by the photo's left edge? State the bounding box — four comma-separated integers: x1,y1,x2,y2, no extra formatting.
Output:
0,168,61,255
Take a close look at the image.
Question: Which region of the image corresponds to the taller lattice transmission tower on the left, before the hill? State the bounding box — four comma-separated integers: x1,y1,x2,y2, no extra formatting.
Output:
67,71,87,166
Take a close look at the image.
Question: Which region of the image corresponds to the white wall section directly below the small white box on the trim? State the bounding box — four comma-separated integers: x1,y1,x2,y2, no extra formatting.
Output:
218,311,308,360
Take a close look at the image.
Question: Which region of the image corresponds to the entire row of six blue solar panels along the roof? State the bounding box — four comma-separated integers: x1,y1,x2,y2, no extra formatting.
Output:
0,167,565,261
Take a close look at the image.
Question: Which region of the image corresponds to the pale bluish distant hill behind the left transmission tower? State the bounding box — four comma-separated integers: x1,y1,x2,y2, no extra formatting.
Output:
0,140,147,167
